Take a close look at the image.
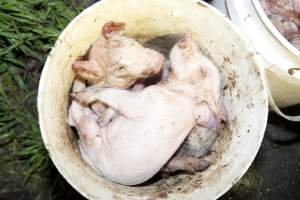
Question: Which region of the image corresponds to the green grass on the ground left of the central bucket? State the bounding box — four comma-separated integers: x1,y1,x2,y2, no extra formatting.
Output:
0,0,86,197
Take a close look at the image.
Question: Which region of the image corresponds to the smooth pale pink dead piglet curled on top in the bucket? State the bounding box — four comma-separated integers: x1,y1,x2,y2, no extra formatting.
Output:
70,34,220,185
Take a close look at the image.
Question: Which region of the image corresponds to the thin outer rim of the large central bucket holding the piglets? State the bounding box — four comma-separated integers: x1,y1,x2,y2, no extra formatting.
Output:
37,0,268,198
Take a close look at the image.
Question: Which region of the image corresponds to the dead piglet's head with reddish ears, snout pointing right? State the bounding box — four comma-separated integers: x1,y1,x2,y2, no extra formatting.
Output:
73,22,164,89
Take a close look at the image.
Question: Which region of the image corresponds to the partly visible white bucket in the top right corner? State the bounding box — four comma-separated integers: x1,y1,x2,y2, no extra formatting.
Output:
226,0,300,121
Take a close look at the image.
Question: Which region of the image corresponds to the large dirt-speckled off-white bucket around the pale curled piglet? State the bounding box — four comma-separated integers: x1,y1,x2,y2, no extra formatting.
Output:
38,0,268,200
